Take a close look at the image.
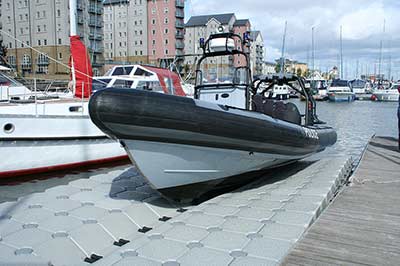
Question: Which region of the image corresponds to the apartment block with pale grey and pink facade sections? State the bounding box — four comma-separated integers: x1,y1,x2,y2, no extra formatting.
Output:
104,0,185,67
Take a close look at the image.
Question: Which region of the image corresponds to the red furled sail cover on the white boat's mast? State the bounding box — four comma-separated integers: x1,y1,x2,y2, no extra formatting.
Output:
70,35,93,98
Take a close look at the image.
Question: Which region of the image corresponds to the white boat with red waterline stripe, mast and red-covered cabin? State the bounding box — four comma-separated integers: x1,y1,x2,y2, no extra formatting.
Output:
0,0,185,178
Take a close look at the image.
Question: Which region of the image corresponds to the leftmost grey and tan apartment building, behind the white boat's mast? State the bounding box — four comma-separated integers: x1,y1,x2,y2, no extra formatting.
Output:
0,0,104,79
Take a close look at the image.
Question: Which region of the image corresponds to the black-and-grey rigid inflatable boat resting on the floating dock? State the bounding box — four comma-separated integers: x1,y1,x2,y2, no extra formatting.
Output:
89,33,336,201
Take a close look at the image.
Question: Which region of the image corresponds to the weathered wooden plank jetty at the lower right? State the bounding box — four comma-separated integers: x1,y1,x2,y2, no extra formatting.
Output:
284,137,400,265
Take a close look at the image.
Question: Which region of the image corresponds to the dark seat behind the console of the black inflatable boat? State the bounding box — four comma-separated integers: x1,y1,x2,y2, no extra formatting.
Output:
252,94,301,125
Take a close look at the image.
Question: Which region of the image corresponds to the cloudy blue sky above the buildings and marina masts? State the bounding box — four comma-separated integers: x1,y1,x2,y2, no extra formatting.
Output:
185,0,400,80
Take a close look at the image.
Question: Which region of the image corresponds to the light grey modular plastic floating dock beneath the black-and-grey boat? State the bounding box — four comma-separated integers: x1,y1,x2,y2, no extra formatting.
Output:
0,157,352,265
